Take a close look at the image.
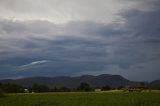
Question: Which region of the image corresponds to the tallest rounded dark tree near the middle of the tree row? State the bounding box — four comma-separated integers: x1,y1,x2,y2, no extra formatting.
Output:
77,82,92,92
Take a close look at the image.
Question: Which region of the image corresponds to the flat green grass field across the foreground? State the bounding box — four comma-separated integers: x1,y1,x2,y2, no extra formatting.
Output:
0,92,160,106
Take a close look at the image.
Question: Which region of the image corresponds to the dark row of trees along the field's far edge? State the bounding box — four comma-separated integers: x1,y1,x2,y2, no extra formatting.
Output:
0,82,111,93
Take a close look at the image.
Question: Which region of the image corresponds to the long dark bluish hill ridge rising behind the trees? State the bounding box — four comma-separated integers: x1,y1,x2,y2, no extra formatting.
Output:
0,74,149,89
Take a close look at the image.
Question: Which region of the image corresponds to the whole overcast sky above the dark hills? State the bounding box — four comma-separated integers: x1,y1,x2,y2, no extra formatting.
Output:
0,0,160,81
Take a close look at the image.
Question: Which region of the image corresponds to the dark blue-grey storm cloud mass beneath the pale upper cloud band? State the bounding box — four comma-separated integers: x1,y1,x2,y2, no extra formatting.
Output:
0,2,160,80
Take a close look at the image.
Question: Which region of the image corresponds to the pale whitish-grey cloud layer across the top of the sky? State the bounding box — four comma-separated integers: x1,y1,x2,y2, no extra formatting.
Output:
0,0,149,23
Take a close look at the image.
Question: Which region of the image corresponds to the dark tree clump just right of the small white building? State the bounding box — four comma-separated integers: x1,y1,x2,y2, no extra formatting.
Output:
32,84,50,92
